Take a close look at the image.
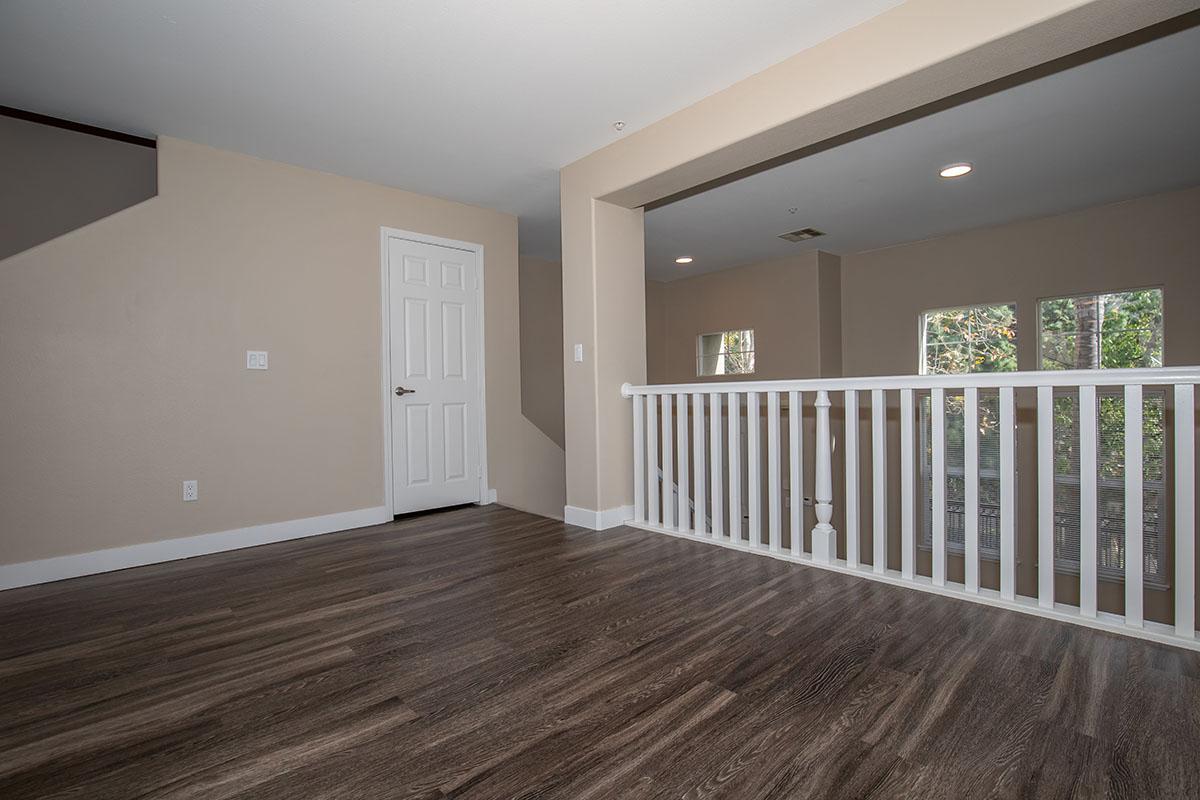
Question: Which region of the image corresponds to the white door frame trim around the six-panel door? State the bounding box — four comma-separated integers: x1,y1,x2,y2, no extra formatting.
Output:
379,225,496,516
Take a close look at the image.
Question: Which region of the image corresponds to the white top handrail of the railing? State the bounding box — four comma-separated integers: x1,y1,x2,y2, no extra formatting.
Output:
620,366,1200,397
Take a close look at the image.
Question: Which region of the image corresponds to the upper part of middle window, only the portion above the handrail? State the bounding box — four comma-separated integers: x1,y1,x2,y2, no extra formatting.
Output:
920,303,1016,375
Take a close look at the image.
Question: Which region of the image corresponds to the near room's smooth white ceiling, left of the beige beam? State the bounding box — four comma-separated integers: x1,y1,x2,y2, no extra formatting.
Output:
0,0,899,258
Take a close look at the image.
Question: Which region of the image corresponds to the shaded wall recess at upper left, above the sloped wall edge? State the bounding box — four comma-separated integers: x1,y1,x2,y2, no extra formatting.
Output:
0,116,157,259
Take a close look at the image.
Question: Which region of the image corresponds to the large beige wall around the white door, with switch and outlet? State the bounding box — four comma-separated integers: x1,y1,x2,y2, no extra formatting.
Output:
0,139,562,563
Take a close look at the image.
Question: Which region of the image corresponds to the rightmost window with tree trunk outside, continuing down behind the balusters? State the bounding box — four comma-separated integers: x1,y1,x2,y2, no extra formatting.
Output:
1038,289,1166,585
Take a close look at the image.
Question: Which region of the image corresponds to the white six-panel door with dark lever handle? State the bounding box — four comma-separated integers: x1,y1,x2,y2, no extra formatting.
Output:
388,236,481,513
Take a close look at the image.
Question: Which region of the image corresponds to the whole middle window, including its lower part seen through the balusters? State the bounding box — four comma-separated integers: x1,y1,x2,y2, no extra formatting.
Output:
920,303,1016,558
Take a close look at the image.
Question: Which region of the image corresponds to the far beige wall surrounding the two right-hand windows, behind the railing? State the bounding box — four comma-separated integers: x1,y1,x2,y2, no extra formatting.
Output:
841,187,1200,621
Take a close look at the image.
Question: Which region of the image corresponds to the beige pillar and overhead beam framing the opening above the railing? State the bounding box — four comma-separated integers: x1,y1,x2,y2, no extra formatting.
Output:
559,0,1180,520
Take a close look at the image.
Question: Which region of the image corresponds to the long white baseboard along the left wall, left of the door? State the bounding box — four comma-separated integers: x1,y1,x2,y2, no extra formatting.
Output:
0,506,392,590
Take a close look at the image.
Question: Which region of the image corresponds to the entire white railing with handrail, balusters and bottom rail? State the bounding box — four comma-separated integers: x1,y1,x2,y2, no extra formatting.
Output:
622,367,1200,649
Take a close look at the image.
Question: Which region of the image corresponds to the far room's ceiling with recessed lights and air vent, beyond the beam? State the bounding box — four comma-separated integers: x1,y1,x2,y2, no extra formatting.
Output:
646,29,1200,281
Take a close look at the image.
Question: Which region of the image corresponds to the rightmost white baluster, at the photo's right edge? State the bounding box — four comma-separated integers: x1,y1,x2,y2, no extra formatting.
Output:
1175,384,1196,639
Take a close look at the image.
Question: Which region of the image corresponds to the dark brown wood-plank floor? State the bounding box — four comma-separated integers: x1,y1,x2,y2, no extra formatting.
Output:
0,506,1200,800
